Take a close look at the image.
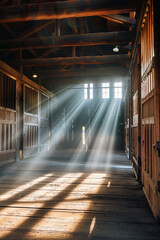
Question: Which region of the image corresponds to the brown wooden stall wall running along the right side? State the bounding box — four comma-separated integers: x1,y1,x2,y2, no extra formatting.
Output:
129,0,160,219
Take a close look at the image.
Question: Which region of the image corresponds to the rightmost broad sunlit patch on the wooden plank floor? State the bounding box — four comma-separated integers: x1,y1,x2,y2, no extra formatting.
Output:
29,173,106,234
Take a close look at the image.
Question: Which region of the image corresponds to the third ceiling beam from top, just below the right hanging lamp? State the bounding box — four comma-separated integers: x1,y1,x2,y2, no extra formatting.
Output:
10,54,130,67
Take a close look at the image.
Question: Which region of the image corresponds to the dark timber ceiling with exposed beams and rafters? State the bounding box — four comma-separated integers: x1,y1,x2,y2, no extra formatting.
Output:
0,0,141,89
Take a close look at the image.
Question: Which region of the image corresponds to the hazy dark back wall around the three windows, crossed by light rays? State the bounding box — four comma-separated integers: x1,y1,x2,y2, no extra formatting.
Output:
53,83,125,151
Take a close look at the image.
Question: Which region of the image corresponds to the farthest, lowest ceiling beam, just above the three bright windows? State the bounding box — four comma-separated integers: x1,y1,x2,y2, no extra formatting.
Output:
27,65,128,79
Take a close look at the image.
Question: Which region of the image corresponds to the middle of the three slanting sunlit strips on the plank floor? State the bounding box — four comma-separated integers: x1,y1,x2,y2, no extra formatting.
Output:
0,173,82,236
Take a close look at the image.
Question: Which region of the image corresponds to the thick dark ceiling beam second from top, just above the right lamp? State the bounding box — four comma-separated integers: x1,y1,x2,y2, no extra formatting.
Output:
0,31,134,51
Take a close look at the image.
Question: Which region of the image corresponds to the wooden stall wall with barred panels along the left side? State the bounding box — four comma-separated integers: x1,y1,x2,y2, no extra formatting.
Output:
0,62,53,164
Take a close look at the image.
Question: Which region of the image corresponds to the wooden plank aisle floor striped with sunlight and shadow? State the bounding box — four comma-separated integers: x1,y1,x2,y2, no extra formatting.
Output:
0,152,160,240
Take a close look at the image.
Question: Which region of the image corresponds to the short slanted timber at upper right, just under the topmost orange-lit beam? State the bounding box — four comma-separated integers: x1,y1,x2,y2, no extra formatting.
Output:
101,14,136,25
